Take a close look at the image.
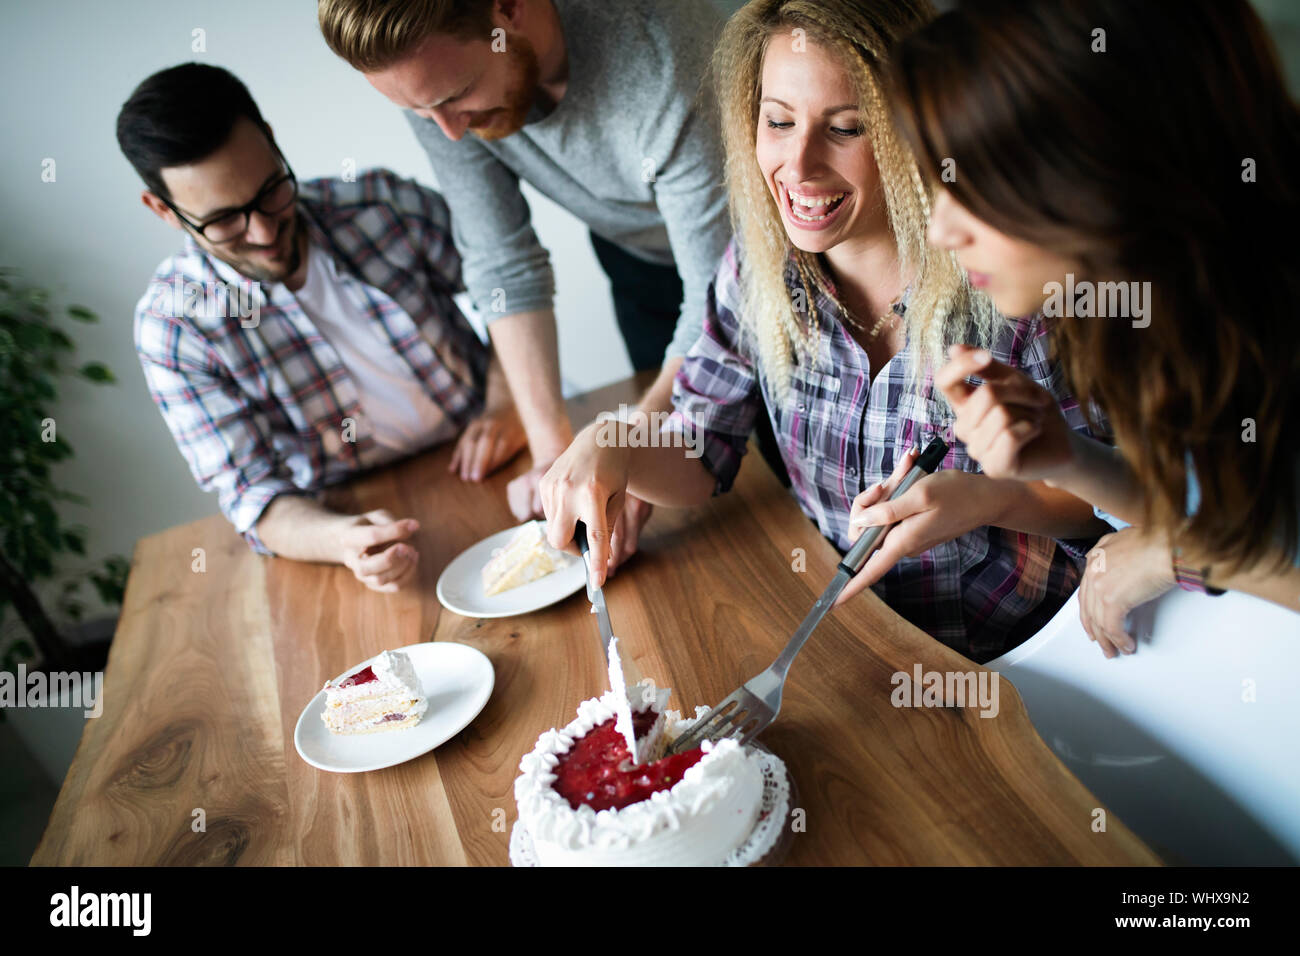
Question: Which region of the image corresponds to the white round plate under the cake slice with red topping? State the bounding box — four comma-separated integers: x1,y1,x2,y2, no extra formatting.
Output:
294,641,497,774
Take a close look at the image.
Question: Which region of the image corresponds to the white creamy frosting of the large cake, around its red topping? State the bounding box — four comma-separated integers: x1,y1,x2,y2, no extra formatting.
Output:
515,682,763,866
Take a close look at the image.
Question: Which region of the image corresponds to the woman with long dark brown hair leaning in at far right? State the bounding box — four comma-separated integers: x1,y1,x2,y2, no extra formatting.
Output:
892,0,1300,657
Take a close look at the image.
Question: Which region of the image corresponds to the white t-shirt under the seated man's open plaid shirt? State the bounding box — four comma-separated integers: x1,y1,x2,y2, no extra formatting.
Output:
294,243,459,460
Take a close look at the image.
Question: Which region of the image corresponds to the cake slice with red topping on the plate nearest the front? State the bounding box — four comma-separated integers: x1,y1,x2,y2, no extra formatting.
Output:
321,650,429,734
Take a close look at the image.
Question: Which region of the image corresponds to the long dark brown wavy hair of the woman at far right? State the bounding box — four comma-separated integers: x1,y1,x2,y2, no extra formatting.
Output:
889,0,1300,570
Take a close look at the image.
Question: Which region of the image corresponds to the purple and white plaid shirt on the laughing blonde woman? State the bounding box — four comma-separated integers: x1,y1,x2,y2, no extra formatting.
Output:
666,239,1095,662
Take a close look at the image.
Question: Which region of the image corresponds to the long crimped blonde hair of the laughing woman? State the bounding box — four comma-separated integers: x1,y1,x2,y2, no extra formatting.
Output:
712,0,997,407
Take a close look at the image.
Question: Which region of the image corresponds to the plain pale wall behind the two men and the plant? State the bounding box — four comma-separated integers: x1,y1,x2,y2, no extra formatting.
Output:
0,0,644,587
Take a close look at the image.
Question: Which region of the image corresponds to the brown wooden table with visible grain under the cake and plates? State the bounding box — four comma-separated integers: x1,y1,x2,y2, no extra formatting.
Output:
33,381,1160,865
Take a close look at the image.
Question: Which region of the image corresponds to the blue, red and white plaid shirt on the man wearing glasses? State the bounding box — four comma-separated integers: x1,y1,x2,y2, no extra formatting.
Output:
135,169,489,554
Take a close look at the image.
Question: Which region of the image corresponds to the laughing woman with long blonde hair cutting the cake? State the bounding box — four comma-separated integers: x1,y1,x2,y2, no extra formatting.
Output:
541,0,1104,661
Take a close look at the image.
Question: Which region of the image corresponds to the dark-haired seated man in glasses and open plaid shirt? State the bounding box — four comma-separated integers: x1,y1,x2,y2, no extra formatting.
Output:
117,64,525,592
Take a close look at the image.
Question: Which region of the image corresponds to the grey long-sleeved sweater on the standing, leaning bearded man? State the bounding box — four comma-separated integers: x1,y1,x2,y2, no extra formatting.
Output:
407,0,731,358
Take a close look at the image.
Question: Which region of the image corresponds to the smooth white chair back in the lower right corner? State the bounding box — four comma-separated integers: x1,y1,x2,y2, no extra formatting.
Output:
988,589,1300,865
